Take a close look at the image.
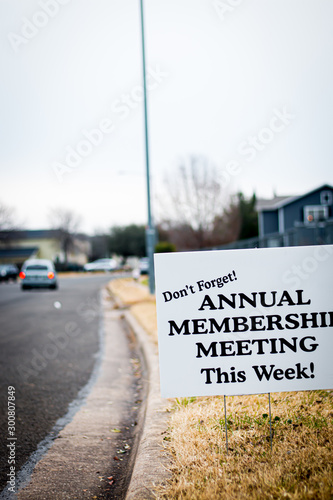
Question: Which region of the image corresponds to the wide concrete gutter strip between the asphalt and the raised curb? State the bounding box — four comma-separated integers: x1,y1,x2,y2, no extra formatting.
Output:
15,289,150,500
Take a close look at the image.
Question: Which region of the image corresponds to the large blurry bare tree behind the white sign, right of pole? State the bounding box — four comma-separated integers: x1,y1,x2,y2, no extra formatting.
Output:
158,156,236,249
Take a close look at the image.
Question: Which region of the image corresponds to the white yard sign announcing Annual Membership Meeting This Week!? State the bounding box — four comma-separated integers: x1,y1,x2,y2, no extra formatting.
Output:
155,245,333,397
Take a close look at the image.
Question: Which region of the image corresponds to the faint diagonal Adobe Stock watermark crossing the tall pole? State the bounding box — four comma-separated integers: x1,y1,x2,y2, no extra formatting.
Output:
52,65,169,183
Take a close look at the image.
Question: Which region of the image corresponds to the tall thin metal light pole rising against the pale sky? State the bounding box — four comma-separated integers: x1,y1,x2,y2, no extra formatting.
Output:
140,0,155,293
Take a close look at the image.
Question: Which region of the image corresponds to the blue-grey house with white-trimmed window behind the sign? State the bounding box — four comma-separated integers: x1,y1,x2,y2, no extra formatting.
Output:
257,184,333,238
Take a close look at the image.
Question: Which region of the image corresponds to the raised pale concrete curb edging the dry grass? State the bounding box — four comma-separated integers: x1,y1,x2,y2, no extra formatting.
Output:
124,311,171,500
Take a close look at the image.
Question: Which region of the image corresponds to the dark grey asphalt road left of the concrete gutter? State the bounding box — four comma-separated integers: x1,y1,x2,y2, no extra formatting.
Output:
0,275,110,491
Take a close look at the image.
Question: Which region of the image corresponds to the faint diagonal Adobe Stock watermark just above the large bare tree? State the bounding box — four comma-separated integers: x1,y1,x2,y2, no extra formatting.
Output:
220,105,295,185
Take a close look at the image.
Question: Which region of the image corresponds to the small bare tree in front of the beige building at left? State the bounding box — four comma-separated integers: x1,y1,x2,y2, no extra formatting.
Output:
49,208,81,263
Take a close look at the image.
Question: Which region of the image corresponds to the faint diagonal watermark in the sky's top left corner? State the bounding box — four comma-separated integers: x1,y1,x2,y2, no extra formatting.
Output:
7,0,71,52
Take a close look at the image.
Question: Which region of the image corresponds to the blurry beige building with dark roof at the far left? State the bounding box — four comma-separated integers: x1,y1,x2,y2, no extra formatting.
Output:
0,229,91,265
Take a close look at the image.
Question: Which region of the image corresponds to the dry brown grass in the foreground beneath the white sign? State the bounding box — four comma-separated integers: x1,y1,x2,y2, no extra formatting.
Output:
160,391,333,500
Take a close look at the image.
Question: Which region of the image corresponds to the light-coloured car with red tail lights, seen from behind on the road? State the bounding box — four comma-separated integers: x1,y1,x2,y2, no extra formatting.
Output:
19,259,58,290
